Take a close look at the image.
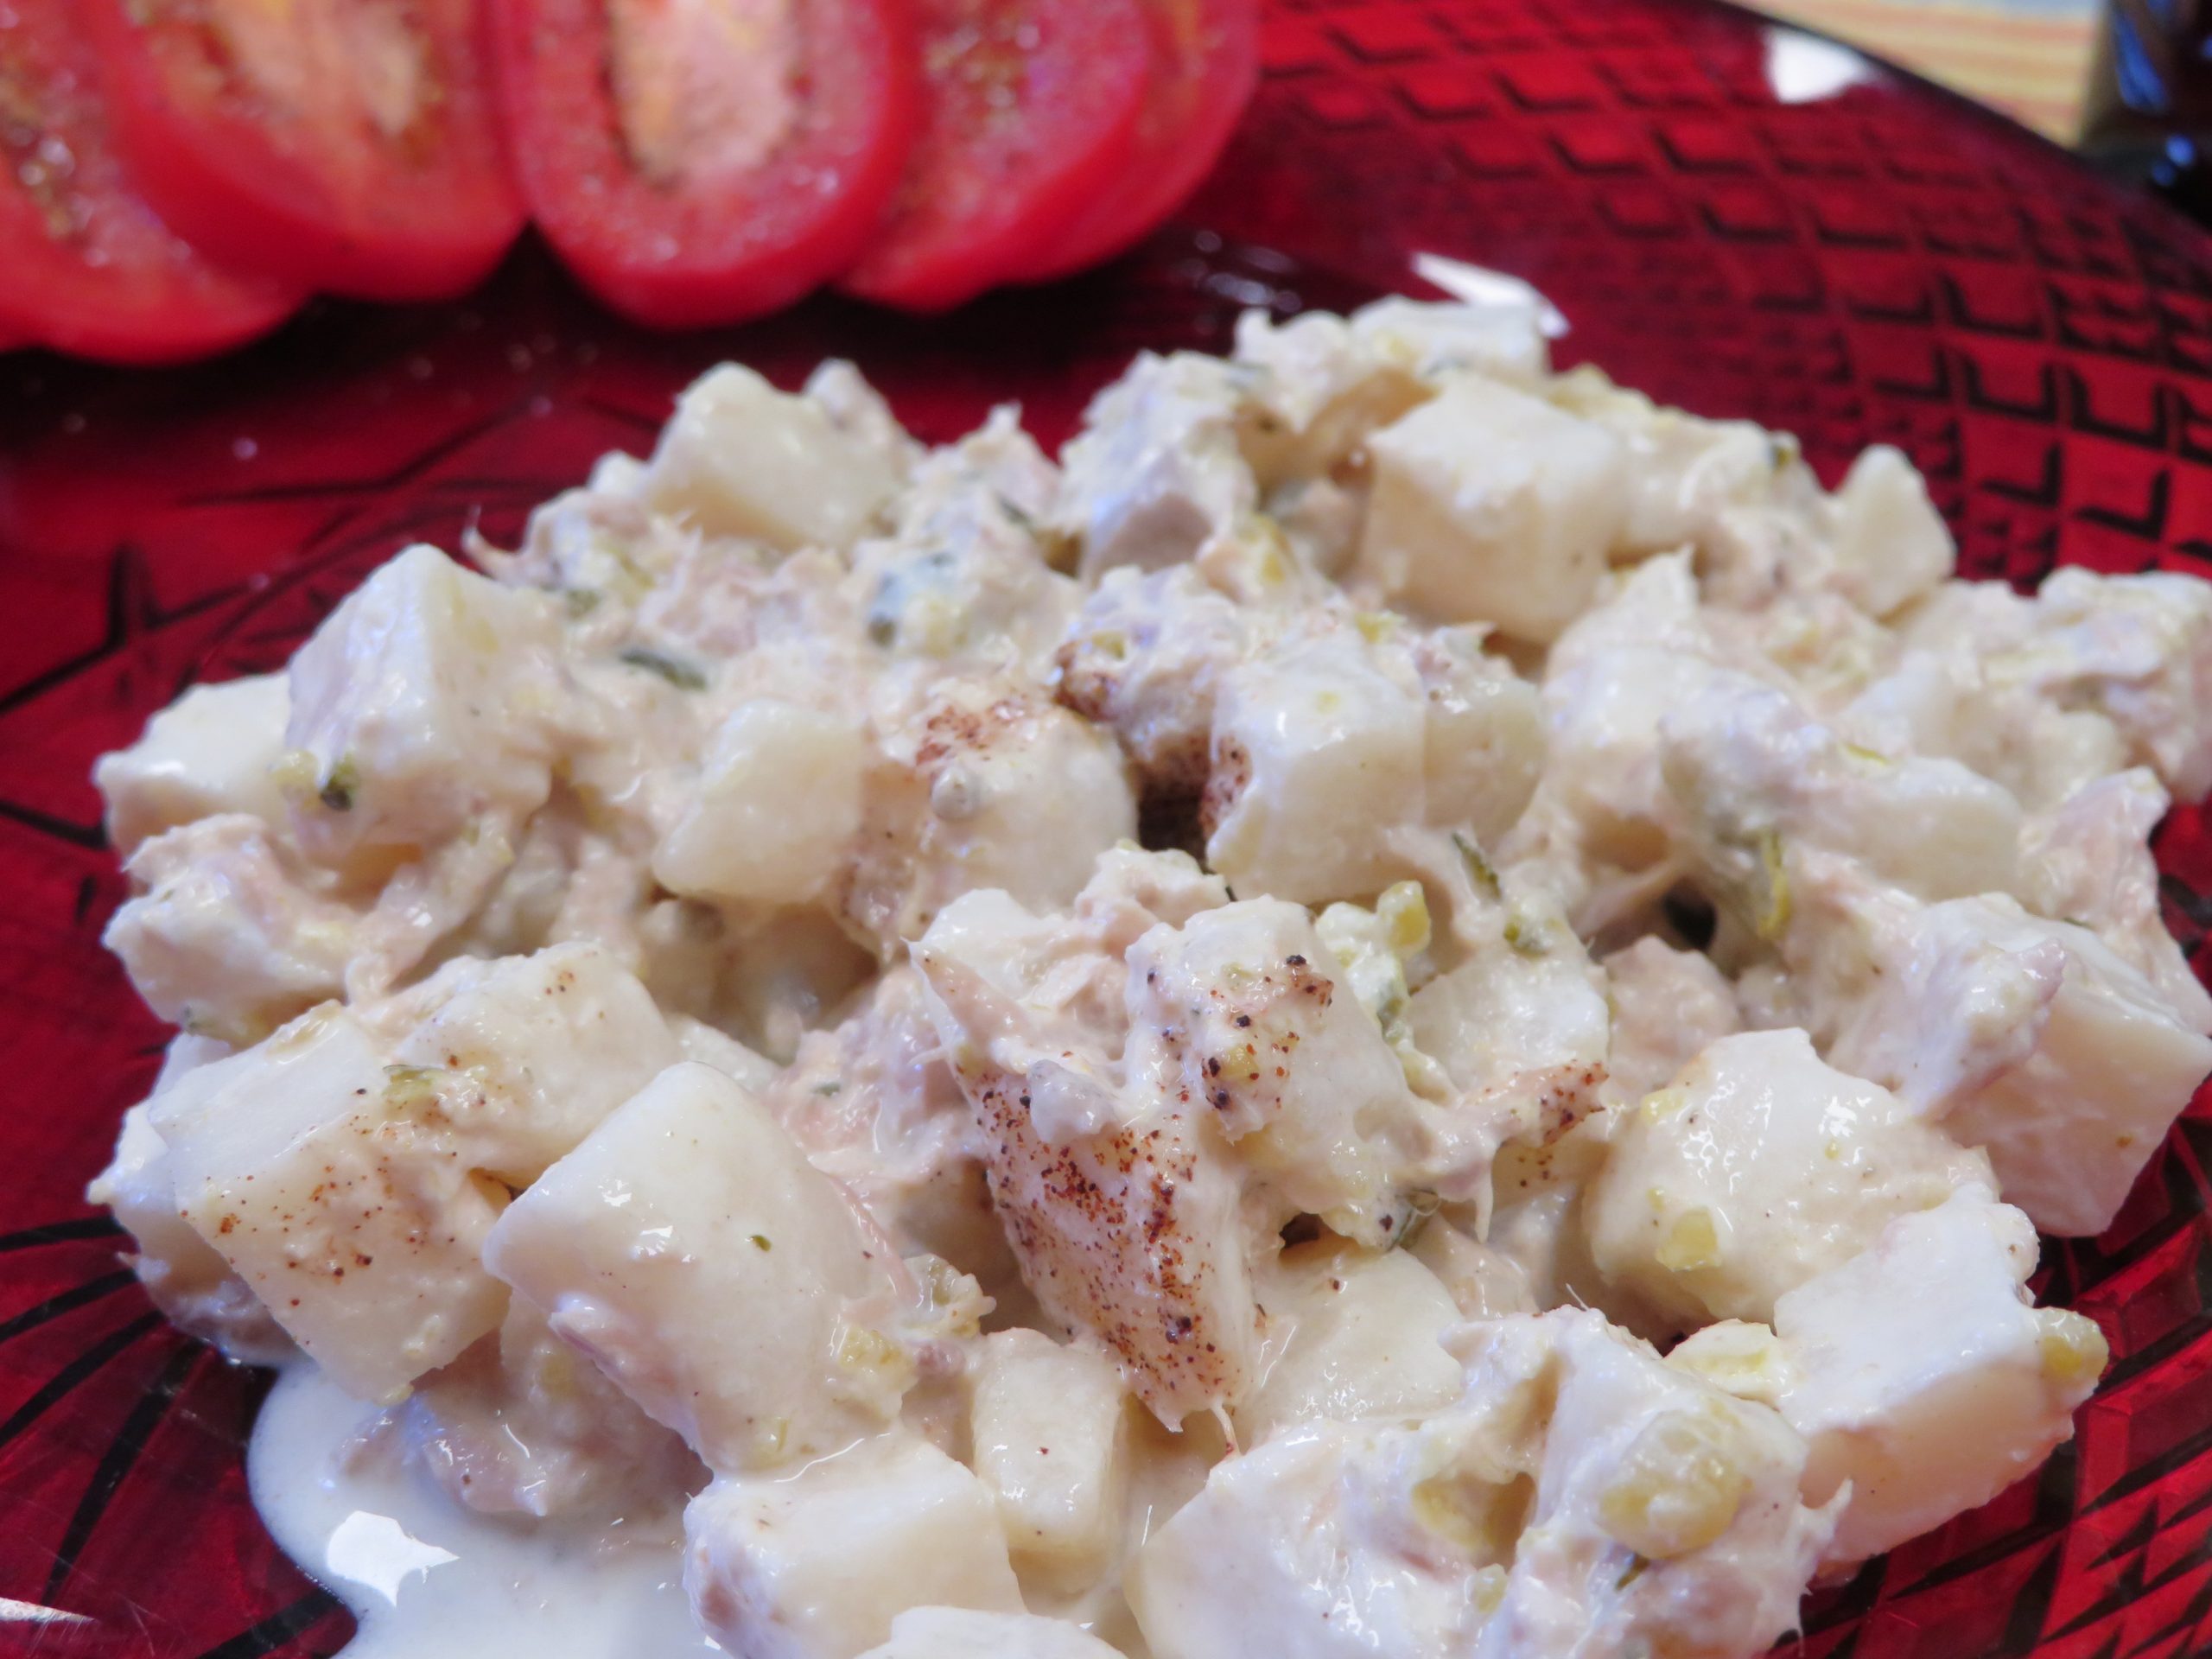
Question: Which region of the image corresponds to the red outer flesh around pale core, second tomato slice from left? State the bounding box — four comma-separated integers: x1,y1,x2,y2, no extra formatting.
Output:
78,0,522,301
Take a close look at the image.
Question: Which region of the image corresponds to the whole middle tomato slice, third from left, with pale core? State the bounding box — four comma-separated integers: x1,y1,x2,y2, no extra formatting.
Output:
489,0,916,327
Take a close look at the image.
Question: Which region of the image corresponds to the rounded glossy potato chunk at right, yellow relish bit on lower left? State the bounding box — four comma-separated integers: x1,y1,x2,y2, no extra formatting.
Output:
1584,1031,1988,1330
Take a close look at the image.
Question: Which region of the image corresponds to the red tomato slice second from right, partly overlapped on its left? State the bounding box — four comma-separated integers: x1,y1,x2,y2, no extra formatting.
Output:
841,0,1153,309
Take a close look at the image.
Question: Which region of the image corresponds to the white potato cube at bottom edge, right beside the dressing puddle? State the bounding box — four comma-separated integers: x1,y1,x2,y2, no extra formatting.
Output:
683,1431,1022,1659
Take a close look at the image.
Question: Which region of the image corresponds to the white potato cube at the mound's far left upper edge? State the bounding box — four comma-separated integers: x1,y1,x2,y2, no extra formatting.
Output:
93,675,292,858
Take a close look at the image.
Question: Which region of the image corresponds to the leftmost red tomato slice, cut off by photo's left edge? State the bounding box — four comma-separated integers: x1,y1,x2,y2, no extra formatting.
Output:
0,0,301,363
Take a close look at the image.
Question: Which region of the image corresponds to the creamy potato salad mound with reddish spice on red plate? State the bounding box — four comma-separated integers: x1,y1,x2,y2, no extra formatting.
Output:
93,283,2212,1659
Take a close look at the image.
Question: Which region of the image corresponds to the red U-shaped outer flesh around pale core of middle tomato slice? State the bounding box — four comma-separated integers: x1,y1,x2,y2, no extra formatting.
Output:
486,0,918,327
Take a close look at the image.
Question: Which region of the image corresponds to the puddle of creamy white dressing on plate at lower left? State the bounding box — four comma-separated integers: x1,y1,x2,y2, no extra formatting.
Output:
245,1365,721,1659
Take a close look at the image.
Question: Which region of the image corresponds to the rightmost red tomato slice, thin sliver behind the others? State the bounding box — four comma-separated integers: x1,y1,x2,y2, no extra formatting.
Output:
1022,0,1259,281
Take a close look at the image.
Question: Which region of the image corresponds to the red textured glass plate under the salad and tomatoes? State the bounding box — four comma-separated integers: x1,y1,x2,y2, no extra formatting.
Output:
0,0,2212,1659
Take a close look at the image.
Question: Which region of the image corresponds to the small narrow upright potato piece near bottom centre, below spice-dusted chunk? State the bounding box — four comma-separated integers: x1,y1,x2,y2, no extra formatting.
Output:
969,1330,1130,1591
